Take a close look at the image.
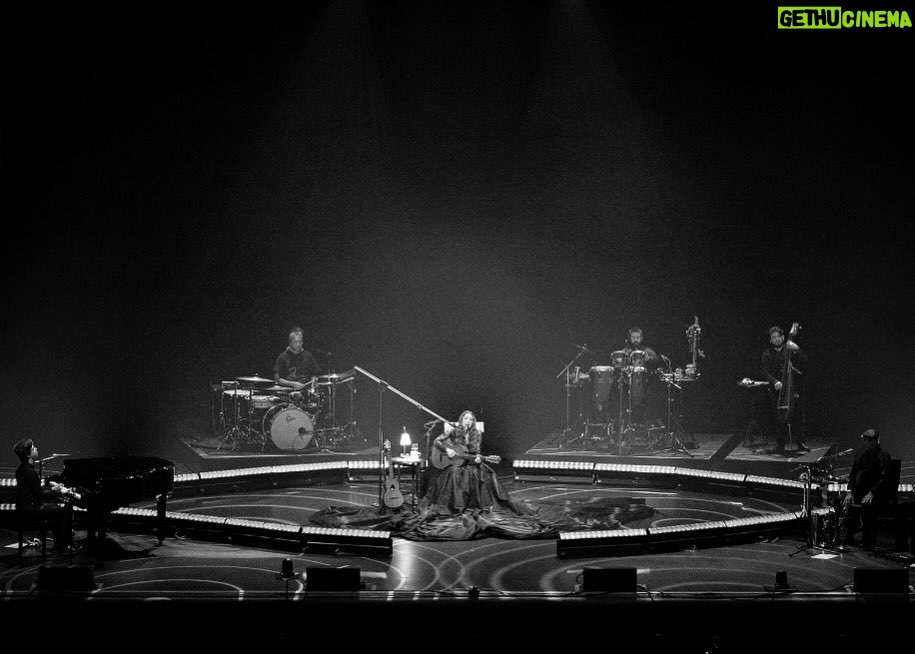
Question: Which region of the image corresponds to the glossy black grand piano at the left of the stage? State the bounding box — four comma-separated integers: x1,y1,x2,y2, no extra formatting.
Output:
49,456,175,550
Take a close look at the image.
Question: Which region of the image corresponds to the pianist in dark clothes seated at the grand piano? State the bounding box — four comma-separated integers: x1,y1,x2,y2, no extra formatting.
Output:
13,438,73,552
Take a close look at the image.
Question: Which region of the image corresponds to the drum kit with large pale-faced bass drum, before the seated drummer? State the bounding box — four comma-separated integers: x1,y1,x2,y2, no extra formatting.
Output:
211,370,358,452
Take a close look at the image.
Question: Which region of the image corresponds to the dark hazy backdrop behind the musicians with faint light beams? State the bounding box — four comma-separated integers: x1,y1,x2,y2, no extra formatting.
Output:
0,1,915,461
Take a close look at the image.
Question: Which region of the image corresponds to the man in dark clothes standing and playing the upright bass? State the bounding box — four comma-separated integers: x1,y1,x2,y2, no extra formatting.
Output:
762,325,810,453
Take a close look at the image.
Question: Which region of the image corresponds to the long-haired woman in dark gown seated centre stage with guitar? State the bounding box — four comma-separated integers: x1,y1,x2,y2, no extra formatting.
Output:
423,411,518,515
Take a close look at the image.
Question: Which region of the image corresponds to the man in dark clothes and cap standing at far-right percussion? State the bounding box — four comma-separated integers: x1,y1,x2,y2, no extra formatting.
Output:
843,429,892,550
